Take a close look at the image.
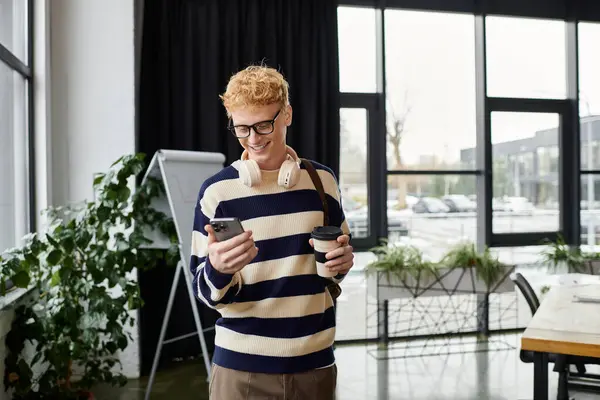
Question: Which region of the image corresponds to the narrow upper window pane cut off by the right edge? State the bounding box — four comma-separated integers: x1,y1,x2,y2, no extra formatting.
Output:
579,23,600,170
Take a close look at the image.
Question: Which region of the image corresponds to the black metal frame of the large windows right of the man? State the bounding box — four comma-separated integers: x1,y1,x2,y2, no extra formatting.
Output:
339,0,600,335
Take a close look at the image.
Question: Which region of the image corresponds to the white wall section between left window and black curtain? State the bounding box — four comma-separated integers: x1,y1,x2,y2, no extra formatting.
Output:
49,0,139,377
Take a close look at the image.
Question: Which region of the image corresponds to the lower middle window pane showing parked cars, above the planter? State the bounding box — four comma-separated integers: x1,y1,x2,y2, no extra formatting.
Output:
387,175,477,261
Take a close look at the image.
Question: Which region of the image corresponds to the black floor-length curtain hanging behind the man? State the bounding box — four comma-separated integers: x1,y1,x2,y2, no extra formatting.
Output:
136,0,340,375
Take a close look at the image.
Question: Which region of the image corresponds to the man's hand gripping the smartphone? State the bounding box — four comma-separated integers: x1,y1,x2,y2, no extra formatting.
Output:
204,224,258,274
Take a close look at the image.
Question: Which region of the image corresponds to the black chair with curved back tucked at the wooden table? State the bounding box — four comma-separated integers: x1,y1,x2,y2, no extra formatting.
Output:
513,272,600,400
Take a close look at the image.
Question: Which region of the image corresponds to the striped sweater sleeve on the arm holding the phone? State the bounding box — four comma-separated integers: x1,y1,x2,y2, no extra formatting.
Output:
190,188,242,309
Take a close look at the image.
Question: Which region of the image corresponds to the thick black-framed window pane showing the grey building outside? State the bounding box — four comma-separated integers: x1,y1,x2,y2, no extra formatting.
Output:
491,112,560,233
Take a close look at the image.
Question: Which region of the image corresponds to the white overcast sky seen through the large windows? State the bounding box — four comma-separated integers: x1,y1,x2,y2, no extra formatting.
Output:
338,7,600,167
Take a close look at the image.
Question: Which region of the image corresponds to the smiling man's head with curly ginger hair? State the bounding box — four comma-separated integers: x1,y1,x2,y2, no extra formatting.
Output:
221,66,292,170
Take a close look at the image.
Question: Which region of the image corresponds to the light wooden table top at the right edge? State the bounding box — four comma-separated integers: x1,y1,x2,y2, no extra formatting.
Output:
521,285,600,358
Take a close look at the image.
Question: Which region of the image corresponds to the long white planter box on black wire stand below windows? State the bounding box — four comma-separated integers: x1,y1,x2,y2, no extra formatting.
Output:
367,266,515,301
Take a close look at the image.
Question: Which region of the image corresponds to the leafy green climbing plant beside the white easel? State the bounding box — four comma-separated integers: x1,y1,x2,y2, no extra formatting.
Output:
0,154,179,400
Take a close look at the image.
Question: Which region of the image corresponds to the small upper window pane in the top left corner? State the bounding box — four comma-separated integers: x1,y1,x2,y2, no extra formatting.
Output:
0,0,28,63
